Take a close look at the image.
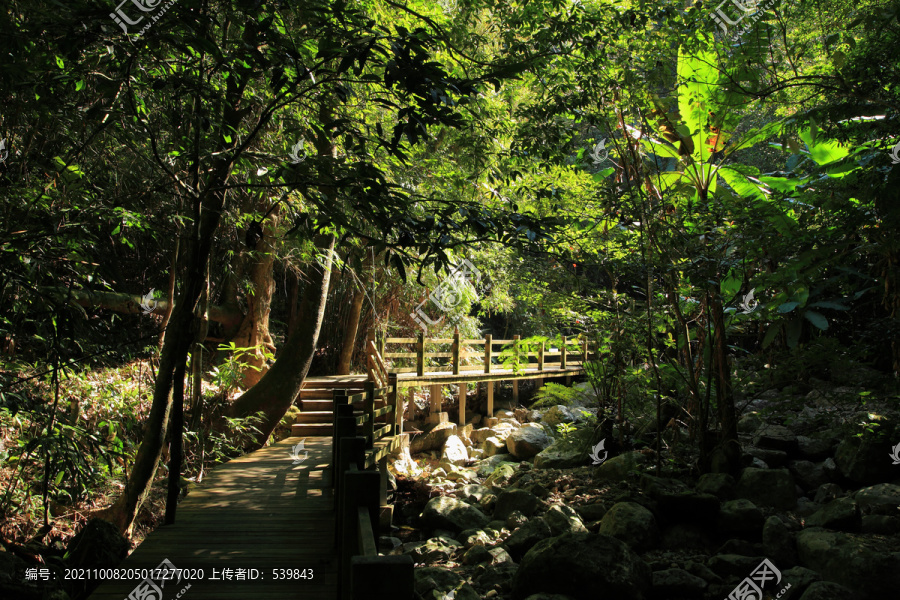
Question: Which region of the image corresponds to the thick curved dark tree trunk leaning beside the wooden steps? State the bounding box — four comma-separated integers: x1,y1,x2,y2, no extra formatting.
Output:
229,236,334,445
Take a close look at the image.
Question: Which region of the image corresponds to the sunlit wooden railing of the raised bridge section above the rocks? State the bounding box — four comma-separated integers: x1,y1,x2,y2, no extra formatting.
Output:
367,330,596,381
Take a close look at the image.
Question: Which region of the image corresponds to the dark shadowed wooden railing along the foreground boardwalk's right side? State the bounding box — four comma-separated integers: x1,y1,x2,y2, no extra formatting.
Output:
332,380,414,600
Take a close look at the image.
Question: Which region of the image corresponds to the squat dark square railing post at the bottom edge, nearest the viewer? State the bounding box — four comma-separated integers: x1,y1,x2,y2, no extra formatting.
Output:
350,555,415,600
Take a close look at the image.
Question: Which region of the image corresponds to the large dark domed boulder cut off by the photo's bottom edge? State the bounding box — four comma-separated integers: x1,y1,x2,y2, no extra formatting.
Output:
512,533,651,600
